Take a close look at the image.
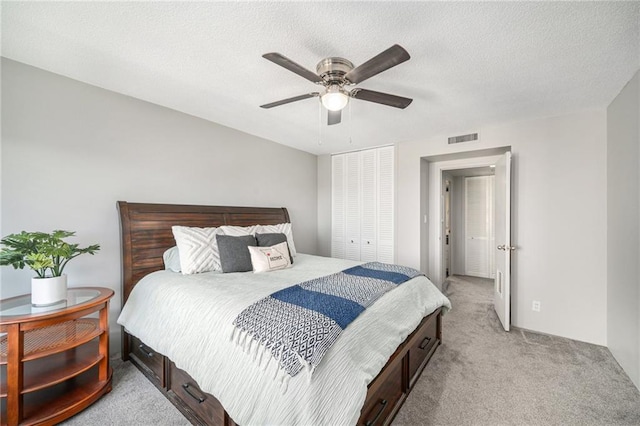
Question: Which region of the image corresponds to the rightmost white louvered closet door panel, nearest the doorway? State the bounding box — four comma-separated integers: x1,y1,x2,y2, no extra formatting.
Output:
376,146,395,263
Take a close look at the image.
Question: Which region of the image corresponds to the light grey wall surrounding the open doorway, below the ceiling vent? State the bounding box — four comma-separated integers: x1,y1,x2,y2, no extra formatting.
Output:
397,110,607,345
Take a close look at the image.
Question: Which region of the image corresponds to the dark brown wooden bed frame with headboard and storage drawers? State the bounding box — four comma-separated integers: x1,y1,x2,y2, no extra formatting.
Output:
118,201,442,426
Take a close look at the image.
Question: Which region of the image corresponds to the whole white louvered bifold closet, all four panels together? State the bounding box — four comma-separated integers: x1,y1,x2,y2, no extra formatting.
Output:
331,146,395,263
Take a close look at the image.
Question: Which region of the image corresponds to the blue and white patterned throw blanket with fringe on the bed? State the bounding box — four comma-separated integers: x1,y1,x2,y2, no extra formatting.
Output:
232,262,422,380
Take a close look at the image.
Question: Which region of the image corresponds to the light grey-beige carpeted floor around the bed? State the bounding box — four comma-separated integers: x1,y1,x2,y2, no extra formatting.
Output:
64,277,640,426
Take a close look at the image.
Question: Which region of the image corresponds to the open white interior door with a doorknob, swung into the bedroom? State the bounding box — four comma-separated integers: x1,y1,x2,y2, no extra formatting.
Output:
493,152,515,331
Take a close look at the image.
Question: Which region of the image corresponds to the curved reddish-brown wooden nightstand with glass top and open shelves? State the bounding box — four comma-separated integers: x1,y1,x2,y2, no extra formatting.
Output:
0,287,113,426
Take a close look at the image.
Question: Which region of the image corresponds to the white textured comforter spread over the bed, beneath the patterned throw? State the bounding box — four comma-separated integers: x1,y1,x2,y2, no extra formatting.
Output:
118,254,451,426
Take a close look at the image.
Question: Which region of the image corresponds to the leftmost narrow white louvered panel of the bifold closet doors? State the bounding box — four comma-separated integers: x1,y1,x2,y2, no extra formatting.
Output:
331,155,347,259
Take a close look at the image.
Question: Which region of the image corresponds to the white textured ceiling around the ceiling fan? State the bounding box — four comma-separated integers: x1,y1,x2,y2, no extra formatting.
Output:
2,1,640,154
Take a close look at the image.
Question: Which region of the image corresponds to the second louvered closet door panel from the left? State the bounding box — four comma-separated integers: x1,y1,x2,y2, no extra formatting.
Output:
345,152,361,260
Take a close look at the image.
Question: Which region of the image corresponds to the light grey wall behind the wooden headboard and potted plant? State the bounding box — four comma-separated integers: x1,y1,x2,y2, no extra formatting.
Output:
0,58,317,352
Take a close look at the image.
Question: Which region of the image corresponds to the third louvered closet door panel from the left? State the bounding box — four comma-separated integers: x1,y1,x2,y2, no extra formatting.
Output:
360,149,378,262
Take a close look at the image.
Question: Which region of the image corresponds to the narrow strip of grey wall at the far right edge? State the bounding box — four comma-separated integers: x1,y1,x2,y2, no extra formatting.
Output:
607,72,640,388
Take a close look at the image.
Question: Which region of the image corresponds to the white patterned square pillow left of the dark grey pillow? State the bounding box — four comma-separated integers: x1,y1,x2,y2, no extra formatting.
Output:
171,226,220,274
